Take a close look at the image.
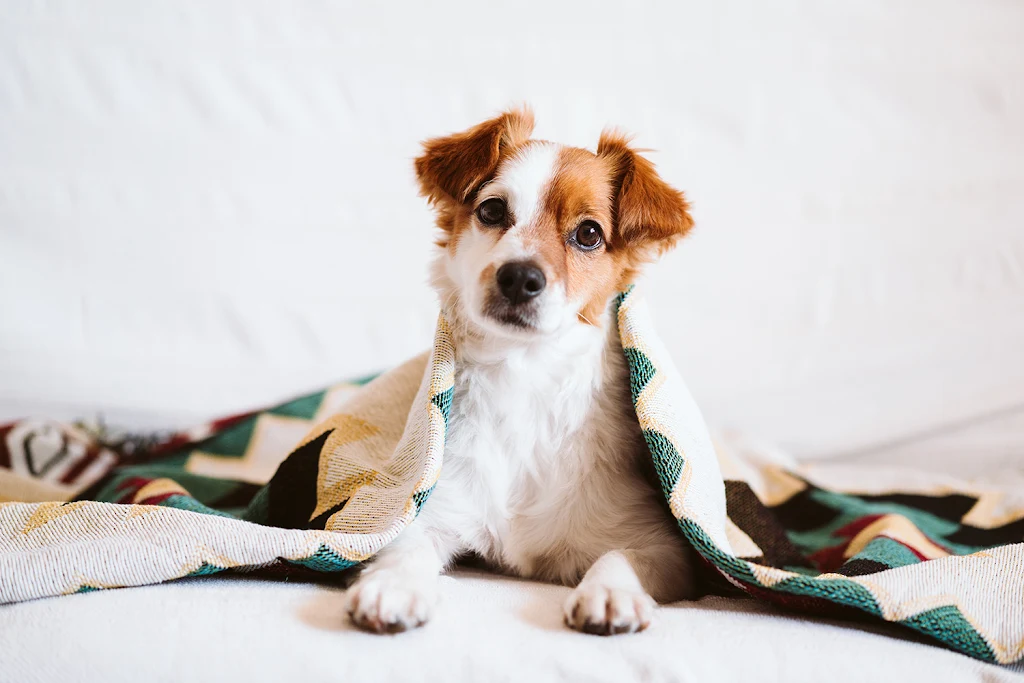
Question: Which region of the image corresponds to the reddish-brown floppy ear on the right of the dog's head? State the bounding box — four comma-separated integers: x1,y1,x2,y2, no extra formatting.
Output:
597,130,693,253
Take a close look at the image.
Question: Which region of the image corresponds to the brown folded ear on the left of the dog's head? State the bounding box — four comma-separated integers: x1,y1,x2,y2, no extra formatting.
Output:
416,108,534,204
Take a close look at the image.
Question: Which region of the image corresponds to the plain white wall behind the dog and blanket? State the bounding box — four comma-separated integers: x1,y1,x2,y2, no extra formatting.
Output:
0,0,1024,465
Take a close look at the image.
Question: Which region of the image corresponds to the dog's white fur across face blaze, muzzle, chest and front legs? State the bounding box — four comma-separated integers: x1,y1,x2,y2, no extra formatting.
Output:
347,145,692,633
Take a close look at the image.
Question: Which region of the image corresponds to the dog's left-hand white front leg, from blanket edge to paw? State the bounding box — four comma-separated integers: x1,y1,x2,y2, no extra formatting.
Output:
345,522,453,633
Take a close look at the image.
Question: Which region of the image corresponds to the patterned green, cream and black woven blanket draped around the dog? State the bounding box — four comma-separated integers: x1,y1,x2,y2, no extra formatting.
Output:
0,292,1024,664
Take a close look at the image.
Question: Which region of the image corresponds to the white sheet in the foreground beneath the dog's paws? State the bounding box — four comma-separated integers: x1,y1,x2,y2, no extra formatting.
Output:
0,570,1024,683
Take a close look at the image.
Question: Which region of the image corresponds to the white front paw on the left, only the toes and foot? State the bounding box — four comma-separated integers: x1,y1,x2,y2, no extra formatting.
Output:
345,571,437,633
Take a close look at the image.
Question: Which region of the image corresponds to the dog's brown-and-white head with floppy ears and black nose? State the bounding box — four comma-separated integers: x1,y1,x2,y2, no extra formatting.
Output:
416,110,692,337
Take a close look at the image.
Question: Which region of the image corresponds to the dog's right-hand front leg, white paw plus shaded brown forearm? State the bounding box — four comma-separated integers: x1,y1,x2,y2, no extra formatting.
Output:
565,546,692,636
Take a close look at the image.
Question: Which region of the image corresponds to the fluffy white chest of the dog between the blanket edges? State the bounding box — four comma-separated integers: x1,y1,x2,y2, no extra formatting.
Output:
432,335,638,580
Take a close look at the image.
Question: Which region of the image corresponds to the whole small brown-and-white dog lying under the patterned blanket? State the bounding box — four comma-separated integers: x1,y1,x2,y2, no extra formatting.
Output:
345,111,694,635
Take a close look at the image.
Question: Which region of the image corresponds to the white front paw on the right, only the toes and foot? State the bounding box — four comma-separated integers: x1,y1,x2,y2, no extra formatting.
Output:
565,584,654,636
